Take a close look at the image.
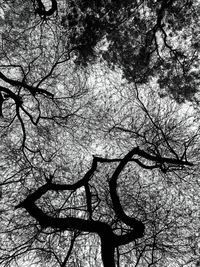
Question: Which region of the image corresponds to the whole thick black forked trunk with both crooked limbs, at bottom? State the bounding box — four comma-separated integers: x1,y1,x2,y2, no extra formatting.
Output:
16,147,192,267
